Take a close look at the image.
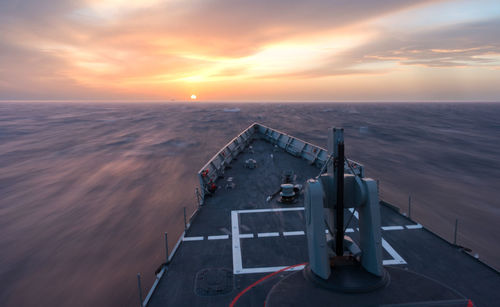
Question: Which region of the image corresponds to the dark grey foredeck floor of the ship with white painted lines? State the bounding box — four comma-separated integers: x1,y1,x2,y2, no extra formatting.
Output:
148,139,500,306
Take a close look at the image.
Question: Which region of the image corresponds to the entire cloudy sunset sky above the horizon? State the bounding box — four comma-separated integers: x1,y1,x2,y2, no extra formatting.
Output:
0,0,500,102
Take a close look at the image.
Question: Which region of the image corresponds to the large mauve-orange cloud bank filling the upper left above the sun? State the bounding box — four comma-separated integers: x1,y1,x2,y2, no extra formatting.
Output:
0,0,440,94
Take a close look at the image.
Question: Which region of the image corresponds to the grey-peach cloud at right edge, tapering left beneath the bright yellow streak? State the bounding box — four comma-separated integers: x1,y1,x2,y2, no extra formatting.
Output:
205,20,500,79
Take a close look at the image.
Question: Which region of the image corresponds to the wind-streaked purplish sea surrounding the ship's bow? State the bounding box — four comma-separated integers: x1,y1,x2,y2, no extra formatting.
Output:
0,103,500,306
